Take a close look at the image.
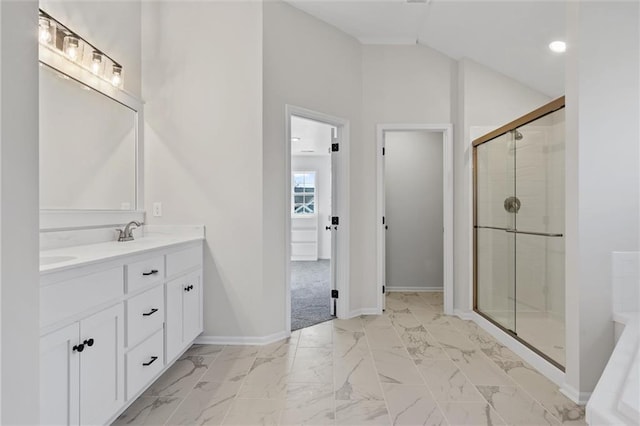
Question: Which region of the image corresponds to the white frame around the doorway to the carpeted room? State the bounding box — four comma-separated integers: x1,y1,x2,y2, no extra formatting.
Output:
284,104,350,333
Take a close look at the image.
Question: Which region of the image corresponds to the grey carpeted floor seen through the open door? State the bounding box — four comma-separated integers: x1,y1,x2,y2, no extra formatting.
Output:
291,260,334,331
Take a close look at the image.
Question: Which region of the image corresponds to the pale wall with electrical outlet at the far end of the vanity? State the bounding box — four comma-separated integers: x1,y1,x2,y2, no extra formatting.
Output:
142,2,264,338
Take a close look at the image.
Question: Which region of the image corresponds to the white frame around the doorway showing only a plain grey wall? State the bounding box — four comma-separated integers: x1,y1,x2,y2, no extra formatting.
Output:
376,123,453,315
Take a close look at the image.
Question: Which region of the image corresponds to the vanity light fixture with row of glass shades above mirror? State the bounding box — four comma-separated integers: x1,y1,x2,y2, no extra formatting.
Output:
38,9,124,89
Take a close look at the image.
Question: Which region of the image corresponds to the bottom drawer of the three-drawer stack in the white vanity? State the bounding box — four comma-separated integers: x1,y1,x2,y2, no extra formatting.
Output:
127,330,164,400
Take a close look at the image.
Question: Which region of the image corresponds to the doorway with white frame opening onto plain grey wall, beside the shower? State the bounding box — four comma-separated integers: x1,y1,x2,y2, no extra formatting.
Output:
377,124,453,315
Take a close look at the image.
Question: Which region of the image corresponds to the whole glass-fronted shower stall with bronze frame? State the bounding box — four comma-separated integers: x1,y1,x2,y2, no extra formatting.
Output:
473,97,565,370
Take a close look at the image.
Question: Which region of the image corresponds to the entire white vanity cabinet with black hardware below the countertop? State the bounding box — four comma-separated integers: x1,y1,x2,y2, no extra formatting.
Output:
40,241,203,425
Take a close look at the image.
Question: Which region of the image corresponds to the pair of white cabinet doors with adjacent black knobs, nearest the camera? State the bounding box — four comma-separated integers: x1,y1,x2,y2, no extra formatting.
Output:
40,304,125,425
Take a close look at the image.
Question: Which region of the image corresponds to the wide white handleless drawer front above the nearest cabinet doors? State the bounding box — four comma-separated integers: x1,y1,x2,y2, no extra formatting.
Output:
40,267,124,327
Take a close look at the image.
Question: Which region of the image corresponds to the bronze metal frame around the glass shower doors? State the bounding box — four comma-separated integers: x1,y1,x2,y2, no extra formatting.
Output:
472,96,565,372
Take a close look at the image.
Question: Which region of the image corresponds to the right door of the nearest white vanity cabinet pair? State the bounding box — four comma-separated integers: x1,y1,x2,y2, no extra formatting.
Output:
80,304,124,425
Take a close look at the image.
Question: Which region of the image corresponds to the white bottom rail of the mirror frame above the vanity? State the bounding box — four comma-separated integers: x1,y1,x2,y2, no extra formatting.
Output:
40,210,145,232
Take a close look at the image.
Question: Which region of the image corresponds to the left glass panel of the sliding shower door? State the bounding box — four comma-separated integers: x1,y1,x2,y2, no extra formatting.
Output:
474,133,516,332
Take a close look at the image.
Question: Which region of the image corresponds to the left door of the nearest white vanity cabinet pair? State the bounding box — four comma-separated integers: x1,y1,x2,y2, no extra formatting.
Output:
40,323,80,425
